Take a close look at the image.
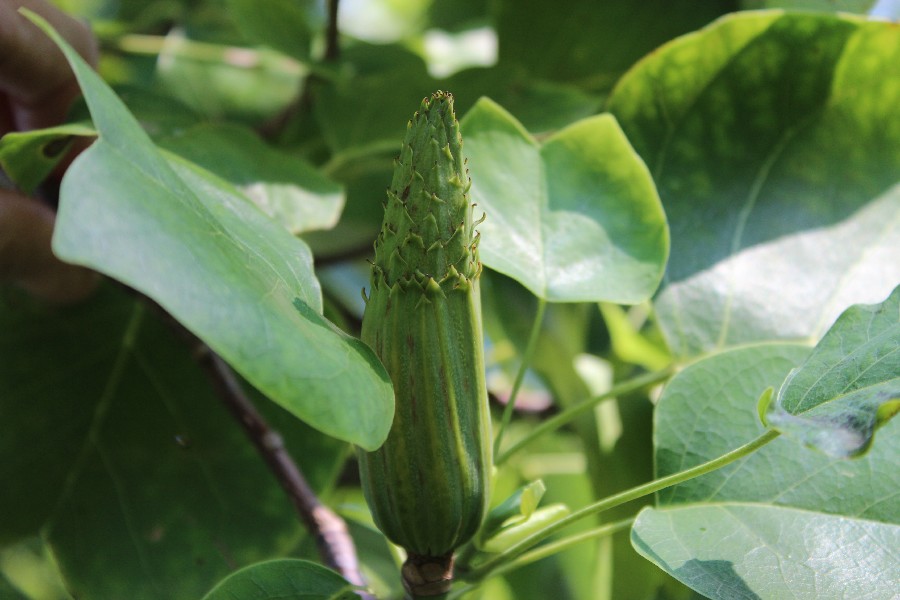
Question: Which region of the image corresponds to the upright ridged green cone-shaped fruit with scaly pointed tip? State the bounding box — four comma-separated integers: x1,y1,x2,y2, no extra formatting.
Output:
359,92,491,596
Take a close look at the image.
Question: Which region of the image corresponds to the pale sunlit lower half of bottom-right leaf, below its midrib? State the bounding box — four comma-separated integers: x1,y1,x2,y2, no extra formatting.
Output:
633,504,900,600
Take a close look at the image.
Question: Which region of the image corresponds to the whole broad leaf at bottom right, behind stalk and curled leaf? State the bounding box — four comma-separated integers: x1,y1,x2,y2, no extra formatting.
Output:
632,344,900,599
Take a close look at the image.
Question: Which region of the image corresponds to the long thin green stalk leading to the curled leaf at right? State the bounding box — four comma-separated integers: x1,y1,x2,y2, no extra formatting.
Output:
465,429,780,581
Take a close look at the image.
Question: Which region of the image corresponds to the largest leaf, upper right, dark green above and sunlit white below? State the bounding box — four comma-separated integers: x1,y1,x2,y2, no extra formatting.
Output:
609,11,900,355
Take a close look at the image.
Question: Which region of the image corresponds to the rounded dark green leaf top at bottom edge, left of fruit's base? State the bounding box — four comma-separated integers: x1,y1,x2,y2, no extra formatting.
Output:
203,558,359,600
